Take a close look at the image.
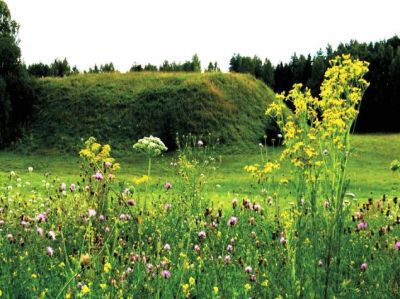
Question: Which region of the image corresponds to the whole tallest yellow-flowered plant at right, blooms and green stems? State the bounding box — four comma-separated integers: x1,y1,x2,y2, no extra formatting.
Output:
266,55,369,297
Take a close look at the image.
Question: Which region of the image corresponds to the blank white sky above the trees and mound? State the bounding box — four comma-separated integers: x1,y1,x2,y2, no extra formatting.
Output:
5,0,400,71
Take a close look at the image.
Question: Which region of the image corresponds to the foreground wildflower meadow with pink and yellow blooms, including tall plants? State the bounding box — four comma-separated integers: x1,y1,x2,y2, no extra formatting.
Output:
0,55,400,298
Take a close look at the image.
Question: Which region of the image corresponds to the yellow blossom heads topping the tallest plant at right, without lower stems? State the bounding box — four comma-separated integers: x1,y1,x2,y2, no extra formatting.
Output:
266,55,368,170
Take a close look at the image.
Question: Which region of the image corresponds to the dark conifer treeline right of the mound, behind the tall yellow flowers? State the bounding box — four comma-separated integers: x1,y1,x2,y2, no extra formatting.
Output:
229,36,400,132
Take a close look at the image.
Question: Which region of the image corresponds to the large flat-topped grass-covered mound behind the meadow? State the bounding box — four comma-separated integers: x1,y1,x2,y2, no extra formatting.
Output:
24,73,274,151
